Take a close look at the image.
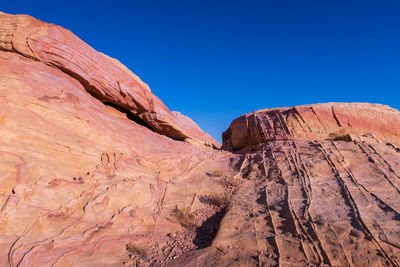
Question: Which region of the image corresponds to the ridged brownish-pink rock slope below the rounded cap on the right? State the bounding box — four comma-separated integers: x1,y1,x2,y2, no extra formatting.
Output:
171,140,400,266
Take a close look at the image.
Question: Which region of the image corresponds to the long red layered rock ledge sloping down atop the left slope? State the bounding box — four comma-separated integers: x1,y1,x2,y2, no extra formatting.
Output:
0,14,219,146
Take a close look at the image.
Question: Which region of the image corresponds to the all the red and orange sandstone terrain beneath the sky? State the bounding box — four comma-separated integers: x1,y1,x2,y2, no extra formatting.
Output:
0,14,400,266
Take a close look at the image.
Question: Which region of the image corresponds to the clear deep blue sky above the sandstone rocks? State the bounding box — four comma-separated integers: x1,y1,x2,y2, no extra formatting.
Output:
0,0,400,141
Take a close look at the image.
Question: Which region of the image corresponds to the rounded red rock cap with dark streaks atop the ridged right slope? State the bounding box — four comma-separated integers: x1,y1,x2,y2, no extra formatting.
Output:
222,103,400,152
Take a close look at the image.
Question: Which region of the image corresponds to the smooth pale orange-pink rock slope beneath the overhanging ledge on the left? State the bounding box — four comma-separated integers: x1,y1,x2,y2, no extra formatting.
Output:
0,23,231,266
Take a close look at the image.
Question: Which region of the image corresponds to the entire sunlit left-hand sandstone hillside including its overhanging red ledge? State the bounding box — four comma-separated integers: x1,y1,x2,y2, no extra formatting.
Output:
0,14,225,266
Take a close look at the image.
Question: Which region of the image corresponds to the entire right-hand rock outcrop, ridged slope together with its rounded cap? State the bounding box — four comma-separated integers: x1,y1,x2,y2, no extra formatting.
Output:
171,103,400,266
